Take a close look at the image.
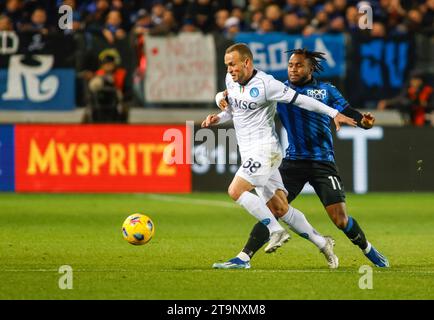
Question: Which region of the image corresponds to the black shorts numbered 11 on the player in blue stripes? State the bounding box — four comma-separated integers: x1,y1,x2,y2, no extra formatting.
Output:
279,159,345,207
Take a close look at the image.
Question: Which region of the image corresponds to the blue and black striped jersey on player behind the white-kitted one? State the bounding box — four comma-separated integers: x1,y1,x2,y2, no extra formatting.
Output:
277,79,349,162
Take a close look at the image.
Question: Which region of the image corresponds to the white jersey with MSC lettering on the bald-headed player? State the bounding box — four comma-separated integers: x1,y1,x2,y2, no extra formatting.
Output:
222,71,297,157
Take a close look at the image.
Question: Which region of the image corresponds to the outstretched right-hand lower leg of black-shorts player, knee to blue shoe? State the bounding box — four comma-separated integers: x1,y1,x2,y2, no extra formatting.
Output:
325,202,389,268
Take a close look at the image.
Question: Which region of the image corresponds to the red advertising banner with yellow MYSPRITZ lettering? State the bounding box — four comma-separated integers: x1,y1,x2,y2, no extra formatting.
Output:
15,125,192,193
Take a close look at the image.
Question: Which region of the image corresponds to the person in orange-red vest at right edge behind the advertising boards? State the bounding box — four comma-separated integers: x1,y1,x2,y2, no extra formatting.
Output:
377,72,434,127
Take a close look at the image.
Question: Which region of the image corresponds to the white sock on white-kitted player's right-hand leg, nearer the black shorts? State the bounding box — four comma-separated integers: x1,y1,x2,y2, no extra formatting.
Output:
281,206,326,249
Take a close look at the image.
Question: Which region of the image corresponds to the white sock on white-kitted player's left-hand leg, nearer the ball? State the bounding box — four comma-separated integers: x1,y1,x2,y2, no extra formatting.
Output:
237,191,284,234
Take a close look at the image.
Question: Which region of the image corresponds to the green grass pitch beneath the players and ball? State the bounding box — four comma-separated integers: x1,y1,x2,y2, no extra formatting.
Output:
0,193,434,300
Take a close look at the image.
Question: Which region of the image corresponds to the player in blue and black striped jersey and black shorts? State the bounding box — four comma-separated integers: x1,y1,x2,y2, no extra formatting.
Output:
217,49,389,267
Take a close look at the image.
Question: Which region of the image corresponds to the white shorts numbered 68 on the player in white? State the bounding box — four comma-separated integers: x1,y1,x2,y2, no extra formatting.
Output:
235,152,288,203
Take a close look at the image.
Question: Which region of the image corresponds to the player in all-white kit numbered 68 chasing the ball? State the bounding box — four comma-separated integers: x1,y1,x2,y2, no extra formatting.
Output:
202,43,356,269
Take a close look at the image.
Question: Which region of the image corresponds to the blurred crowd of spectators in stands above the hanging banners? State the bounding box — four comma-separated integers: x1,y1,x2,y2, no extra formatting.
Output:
0,0,434,36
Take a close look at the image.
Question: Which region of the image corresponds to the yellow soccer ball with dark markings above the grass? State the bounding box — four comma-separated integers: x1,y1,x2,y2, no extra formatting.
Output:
122,213,155,245
